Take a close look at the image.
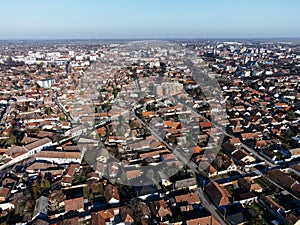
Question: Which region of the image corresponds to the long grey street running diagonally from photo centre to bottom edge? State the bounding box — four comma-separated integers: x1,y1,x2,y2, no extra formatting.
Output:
133,112,228,225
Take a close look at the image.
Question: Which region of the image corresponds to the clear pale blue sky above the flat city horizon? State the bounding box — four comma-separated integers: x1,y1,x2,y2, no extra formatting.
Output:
0,0,300,39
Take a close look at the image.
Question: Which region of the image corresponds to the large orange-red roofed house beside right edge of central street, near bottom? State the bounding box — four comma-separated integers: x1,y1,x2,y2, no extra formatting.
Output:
206,182,232,206
